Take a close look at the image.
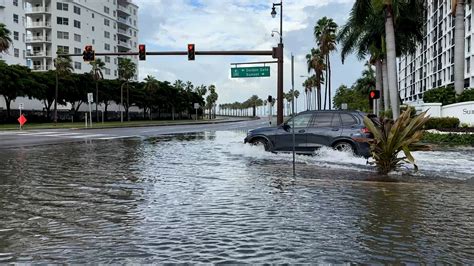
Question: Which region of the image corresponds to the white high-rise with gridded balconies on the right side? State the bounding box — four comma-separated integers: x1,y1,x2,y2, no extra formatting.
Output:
398,0,474,102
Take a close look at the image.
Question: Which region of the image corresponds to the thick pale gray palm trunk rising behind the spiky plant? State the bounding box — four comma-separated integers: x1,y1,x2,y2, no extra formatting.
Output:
385,5,400,120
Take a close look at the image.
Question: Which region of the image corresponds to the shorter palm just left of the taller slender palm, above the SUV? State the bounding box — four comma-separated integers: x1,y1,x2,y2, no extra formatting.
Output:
306,48,326,110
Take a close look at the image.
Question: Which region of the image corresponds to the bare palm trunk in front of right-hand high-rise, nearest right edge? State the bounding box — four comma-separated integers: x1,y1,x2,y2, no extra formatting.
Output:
454,0,465,94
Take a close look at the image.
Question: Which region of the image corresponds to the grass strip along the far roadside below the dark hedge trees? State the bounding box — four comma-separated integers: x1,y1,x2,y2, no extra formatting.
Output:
0,117,251,130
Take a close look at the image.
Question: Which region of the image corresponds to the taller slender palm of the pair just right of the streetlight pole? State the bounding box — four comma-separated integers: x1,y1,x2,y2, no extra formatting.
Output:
314,17,337,110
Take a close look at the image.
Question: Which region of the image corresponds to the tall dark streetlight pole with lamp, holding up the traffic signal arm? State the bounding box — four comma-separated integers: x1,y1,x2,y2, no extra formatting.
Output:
270,0,283,124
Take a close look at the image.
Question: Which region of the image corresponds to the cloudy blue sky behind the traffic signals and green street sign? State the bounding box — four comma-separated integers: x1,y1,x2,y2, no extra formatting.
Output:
134,0,364,110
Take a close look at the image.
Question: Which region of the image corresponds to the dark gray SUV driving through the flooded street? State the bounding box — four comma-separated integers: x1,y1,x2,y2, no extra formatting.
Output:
244,110,373,158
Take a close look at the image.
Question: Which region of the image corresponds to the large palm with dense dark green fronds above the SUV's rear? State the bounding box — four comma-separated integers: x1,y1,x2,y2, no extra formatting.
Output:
338,0,426,118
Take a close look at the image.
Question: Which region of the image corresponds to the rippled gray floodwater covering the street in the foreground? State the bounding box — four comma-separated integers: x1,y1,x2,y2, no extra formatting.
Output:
0,131,474,264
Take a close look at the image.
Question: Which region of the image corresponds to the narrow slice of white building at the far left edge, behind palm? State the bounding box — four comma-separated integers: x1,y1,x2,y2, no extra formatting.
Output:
0,0,26,65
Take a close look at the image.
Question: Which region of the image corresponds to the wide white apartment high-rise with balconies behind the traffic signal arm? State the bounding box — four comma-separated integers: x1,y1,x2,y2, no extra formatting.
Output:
25,0,138,79
